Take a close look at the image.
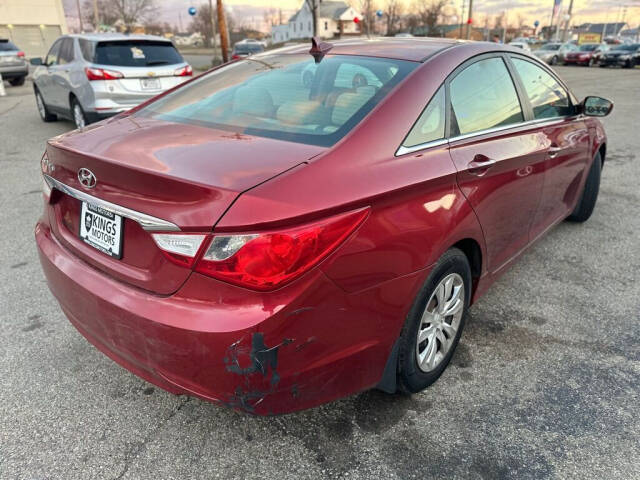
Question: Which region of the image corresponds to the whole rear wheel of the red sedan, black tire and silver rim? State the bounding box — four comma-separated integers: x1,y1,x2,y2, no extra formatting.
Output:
398,248,471,393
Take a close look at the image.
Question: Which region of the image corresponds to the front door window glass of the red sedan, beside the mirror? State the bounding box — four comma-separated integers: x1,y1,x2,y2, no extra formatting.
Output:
512,58,572,119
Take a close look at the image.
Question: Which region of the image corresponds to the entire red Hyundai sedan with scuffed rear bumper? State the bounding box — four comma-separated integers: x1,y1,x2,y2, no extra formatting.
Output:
35,39,612,414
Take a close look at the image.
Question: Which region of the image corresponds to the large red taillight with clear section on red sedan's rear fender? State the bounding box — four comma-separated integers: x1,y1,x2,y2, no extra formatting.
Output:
195,209,369,290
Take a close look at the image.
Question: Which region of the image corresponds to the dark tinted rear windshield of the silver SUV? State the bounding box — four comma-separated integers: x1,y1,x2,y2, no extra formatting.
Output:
93,40,184,67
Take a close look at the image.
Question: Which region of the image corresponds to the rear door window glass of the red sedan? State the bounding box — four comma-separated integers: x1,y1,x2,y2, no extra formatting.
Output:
449,58,524,136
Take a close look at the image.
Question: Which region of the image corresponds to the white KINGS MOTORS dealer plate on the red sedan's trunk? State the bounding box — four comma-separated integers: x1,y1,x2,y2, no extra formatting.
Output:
80,202,122,258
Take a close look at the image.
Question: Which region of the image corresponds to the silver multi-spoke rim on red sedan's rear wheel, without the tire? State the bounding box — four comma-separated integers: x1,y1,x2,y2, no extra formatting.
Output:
416,273,465,372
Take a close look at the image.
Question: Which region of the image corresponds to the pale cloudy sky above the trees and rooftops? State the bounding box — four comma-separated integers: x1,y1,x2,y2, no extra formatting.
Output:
64,0,640,29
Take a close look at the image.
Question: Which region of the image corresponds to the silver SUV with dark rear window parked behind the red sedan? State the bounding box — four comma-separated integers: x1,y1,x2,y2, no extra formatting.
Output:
31,34,193,128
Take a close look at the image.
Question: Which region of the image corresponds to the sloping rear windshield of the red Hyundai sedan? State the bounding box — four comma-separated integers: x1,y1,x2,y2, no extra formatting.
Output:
135,54,419,146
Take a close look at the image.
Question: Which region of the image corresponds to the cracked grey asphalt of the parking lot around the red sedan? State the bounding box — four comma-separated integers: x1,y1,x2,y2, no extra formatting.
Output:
0,67,640,480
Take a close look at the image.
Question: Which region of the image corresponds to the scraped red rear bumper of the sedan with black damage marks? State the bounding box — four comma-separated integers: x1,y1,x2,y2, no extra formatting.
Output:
35,222,428,415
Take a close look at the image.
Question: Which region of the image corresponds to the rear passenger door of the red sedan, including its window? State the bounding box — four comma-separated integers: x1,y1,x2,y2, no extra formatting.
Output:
446,54,546,272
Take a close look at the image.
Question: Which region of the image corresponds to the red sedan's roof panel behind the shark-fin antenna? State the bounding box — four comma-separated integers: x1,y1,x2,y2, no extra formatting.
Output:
265,37,465,62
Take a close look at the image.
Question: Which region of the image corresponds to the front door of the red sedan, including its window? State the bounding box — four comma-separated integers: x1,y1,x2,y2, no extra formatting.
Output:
510,55,589,237
